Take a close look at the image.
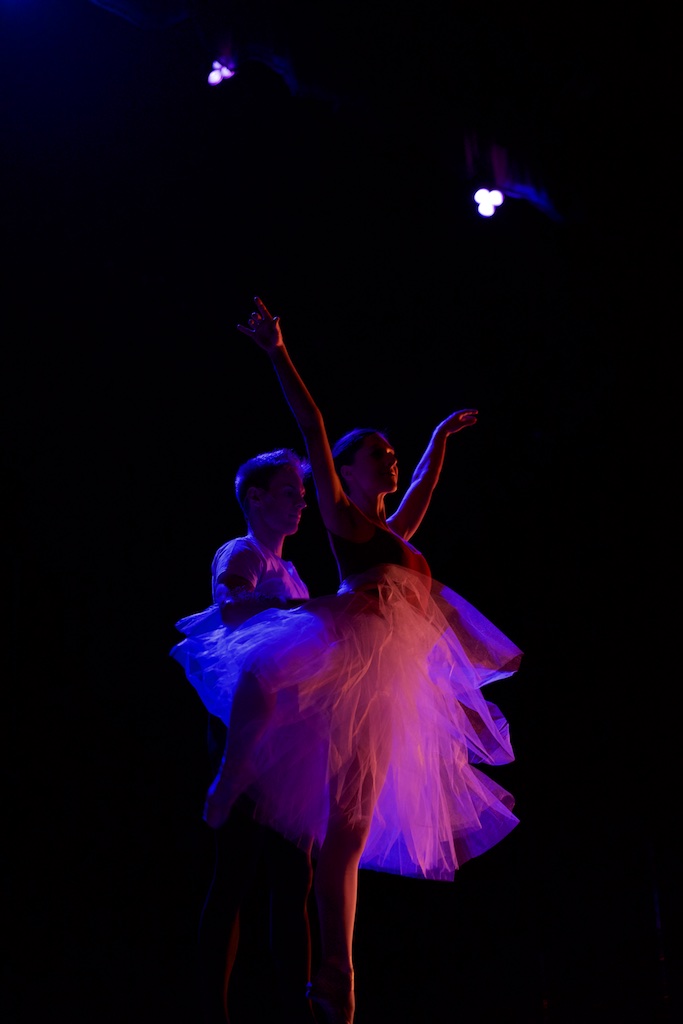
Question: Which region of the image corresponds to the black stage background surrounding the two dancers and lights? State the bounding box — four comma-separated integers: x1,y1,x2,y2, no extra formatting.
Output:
0,0,681,1024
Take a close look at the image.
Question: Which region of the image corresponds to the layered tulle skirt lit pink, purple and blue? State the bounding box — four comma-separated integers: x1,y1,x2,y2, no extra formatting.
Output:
171,565,522,879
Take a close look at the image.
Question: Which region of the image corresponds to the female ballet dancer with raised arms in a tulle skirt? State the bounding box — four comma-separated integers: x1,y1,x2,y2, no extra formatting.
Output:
179,298,522,1024
